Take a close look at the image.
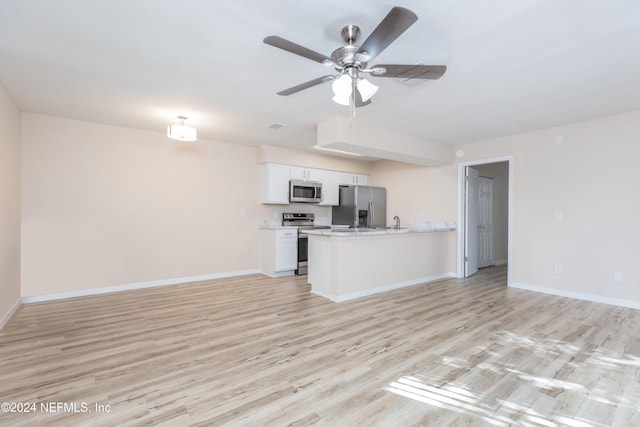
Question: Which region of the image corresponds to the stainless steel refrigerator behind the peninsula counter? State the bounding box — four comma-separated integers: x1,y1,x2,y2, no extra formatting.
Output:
331,185,387,228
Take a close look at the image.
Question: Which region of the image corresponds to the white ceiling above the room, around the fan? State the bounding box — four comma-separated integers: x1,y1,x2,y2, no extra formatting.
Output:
0,0,640,157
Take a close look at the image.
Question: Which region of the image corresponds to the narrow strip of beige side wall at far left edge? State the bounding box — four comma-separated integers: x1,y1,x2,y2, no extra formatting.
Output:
0,86,20,327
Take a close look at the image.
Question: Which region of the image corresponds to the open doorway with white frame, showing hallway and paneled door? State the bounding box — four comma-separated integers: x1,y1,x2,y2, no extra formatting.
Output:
457,156,513,283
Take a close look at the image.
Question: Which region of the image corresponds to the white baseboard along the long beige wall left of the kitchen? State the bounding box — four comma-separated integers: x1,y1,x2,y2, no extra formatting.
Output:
22,268,260,304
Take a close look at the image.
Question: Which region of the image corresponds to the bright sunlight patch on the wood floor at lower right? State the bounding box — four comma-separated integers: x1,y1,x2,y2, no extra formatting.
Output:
384,331,640,427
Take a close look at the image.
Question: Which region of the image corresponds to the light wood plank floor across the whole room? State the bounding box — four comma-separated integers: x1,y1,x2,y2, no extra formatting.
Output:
0,267,640,427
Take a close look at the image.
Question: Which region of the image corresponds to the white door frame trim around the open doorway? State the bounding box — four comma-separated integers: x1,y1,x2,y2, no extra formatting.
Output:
456,156,514,286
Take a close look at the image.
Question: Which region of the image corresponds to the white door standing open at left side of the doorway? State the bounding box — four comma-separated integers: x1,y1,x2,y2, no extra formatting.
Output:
464,166,480,277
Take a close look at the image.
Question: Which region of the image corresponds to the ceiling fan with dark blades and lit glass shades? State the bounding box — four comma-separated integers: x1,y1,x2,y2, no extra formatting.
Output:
263,7,447,107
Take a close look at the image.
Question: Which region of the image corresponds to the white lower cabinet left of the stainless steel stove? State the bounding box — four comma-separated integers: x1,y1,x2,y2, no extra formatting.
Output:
260,227,298,277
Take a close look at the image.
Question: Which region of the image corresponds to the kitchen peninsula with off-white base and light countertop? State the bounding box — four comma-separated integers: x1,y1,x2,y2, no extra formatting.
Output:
303,223,455,302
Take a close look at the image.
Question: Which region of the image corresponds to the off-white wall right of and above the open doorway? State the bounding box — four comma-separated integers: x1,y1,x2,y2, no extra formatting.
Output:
458,112,640,306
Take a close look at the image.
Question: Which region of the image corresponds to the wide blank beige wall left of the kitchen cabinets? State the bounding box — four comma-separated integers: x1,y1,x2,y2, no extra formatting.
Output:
22,113,270,296
